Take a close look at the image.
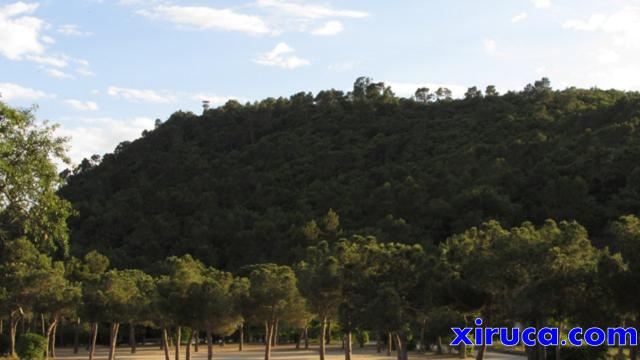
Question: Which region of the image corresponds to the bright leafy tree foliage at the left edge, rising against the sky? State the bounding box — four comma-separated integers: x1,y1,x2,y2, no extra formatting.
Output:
0,102,71,257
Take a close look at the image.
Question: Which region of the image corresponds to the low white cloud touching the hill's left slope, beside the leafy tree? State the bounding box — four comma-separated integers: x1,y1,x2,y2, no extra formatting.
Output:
57,117,154,163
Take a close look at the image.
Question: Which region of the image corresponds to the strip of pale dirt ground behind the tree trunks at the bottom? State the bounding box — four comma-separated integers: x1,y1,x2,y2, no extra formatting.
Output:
48,345,522,360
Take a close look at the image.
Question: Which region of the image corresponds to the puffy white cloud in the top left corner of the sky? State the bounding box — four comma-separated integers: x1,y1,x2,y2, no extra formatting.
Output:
0,1,45,60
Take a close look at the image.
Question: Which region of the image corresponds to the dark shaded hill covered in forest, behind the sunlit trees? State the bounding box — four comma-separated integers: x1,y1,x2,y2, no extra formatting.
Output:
61,81,640,269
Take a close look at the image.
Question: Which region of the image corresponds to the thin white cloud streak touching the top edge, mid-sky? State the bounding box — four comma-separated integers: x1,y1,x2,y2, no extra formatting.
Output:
257,0,369,19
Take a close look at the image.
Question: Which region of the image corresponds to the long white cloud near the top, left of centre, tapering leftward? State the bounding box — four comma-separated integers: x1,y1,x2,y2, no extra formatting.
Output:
138,5,272,35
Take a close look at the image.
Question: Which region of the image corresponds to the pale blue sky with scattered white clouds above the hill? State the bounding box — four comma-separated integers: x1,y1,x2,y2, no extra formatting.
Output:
0,0,640,164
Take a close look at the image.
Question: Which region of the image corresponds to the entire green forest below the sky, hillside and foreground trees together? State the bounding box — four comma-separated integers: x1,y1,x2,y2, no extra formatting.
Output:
0,78,640,360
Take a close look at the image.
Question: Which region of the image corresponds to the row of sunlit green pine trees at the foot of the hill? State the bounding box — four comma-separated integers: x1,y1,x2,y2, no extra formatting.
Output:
0,208,640,360
